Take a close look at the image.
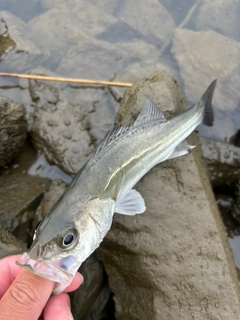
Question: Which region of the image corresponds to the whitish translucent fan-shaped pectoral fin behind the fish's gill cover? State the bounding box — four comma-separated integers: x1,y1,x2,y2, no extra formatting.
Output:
115,189,146,215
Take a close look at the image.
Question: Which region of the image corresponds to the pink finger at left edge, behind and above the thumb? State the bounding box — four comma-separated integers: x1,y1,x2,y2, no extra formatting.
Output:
0,255,22,299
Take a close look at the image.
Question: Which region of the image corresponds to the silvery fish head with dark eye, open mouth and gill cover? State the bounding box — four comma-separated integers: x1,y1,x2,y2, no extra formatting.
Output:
17,199,113,294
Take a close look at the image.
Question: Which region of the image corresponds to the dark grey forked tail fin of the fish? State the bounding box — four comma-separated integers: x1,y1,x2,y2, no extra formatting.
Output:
199,79,217,127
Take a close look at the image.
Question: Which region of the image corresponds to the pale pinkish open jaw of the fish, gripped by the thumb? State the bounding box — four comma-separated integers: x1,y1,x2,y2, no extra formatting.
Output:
16,252,79,295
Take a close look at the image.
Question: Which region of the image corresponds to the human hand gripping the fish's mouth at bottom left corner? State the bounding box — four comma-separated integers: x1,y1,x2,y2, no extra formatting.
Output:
0,255,83,320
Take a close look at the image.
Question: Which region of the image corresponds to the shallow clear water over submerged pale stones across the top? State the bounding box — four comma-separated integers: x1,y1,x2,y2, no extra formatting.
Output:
0,0,240,141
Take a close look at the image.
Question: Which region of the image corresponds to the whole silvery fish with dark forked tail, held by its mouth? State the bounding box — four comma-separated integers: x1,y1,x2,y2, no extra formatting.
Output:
16,80,217,294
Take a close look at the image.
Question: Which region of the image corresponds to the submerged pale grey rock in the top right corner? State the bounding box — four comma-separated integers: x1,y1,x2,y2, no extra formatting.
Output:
196,0,240,41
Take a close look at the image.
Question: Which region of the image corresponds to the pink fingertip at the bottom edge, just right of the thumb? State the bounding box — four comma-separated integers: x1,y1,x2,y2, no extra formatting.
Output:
43,293,73,320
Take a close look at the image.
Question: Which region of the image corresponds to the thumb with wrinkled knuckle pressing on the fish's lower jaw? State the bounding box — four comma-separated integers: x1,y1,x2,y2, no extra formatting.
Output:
0,270,54,320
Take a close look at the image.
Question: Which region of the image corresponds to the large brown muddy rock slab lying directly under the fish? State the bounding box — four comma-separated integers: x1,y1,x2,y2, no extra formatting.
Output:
98,73,240,320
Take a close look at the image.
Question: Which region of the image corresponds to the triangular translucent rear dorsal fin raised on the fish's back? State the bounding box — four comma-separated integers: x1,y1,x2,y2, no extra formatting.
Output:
133,97,167,126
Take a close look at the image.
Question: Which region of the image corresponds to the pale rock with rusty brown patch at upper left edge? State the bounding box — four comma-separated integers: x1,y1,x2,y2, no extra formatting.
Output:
0,11,48,72
